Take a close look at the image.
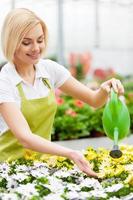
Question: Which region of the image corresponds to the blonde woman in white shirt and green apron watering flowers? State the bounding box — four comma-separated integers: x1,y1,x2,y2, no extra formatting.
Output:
0,8,124,176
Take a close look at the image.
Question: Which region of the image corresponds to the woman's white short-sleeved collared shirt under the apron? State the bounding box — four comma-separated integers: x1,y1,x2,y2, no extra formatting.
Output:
0,59,71,135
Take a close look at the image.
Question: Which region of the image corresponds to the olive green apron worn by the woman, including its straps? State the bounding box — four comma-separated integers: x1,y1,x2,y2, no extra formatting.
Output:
0,79,57,161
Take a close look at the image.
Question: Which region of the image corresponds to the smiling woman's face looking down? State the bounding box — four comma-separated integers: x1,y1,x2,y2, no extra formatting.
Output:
14,24,45,65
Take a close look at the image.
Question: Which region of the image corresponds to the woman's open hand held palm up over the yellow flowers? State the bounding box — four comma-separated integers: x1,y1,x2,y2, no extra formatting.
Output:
68,151,98,177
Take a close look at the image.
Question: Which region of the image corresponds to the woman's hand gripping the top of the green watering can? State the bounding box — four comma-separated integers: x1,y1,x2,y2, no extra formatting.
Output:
100,78,124,95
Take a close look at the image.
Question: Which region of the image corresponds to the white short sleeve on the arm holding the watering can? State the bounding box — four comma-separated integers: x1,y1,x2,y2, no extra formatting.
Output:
45,60,71,88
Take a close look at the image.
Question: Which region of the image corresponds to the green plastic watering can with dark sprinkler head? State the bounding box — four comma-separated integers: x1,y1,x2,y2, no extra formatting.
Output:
102,89,130,158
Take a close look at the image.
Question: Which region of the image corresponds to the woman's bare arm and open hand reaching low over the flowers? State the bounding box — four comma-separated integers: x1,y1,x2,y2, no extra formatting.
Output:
0,103,97,176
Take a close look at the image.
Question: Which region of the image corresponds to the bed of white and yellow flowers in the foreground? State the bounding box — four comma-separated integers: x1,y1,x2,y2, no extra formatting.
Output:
0,146,133,200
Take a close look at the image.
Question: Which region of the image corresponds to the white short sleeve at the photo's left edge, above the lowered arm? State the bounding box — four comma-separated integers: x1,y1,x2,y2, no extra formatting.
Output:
0,77,15,103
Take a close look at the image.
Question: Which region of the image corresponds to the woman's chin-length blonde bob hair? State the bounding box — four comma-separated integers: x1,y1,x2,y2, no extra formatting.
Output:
1,8,48,62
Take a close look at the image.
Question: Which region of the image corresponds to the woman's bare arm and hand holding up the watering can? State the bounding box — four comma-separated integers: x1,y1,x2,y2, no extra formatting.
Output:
60,77,124,108
